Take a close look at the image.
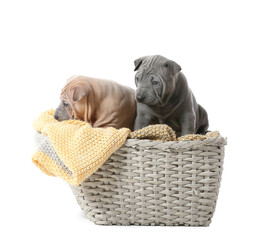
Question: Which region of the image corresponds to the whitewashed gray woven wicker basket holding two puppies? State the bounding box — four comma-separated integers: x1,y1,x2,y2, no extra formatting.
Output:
71,137,226,226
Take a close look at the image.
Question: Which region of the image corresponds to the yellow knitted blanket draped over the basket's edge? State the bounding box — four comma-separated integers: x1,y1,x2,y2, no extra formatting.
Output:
32,109,219,186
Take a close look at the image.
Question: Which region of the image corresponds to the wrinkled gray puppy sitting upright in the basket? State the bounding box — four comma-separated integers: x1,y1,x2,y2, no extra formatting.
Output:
134,55,209,136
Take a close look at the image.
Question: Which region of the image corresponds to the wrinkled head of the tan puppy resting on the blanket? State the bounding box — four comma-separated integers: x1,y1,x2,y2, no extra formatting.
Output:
54,76,93,122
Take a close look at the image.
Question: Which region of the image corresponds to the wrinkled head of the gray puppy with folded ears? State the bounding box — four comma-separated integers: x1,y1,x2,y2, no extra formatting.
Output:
134,55,181,106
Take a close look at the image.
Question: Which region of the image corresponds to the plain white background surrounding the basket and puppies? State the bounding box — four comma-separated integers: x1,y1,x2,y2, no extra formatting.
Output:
0,0,271,240
